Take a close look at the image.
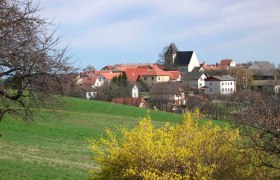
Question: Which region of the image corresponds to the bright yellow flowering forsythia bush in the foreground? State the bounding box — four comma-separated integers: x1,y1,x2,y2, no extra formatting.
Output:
89,111,266,180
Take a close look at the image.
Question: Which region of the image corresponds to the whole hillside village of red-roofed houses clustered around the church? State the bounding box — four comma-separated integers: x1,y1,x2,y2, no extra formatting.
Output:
76,43,280,112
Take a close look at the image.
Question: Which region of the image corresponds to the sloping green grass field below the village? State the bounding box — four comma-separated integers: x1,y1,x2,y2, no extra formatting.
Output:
0,98,228,180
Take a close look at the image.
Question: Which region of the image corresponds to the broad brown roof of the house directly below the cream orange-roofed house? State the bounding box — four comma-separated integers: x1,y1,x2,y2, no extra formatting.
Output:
149,82,184,94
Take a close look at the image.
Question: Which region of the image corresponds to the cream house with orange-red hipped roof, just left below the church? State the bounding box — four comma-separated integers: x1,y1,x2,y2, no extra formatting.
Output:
140,67,170,88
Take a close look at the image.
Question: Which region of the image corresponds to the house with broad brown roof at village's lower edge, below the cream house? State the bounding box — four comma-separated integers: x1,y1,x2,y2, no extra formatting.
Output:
149,82,185,110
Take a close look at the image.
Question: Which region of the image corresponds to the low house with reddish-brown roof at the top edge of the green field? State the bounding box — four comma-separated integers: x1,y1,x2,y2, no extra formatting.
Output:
111,97,149,108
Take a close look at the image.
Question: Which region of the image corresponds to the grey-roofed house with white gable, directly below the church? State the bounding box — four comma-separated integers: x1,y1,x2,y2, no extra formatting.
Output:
183,72,207,89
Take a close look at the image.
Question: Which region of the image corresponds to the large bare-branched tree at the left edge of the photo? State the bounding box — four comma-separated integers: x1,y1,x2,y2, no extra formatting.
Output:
0,0,73,120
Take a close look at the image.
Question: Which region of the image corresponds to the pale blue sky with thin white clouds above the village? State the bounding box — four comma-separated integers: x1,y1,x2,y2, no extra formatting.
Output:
34,0,280,69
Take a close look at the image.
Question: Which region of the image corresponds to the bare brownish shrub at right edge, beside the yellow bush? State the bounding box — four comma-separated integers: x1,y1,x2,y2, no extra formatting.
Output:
233,91,280,173
